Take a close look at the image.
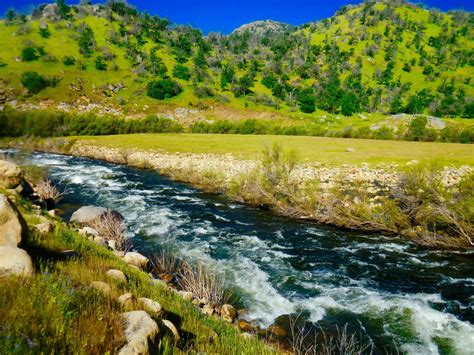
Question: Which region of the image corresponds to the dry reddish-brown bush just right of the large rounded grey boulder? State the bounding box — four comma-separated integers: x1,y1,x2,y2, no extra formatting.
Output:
89,209,132,252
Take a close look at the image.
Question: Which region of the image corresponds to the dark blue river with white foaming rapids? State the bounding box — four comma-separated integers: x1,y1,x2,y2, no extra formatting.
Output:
5,153,474,354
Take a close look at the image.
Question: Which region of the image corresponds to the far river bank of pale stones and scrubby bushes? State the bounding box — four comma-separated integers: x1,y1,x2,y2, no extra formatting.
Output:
3,138,473,249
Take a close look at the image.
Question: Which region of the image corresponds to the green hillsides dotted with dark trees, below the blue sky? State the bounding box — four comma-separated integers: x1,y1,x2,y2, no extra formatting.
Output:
0,1,474,119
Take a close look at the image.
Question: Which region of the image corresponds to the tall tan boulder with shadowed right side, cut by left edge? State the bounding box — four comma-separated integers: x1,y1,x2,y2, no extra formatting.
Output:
0,194,28,247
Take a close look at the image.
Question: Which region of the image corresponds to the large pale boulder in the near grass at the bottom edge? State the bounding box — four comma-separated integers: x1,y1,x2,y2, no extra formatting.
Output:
118,311,159,355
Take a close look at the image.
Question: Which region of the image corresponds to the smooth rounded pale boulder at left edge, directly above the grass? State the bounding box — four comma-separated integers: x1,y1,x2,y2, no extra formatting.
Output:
0,245,33,277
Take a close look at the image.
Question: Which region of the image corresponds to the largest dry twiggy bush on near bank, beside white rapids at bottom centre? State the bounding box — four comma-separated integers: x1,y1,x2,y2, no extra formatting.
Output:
178,263,229,307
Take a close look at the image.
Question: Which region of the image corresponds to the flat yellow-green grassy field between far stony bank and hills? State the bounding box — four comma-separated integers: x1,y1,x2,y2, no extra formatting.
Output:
78,134,474,166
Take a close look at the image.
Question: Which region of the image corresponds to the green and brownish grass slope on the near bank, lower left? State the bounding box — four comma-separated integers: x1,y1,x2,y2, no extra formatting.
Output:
0,196,278,354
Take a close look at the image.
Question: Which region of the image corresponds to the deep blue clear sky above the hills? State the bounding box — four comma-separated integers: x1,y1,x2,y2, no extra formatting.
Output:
0,0,474,33
